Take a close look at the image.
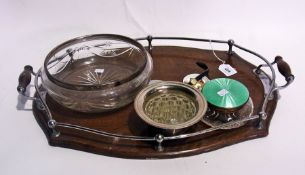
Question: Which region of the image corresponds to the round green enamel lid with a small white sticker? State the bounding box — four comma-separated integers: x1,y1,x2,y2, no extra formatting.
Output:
201,78,249,109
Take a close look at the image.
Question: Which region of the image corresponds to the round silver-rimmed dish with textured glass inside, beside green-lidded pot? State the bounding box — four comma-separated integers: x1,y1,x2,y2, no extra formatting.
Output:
134,81,207,135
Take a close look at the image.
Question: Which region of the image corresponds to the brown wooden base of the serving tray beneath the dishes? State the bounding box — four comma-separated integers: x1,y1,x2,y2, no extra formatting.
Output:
33,46,278,159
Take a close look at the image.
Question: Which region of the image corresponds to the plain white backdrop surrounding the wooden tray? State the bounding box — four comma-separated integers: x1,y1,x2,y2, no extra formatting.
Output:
0,0,305,175
